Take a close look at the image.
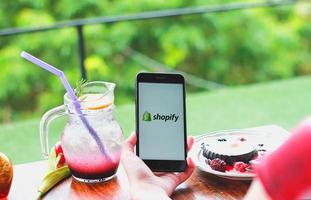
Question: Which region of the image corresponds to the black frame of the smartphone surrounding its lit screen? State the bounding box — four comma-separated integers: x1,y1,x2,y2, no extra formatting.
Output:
135,73,187,172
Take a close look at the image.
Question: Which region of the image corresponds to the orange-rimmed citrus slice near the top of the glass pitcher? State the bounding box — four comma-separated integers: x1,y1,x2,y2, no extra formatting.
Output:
79,94,113,110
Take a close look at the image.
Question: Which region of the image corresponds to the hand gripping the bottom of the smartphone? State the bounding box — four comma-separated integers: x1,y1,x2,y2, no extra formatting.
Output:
121,133,195,199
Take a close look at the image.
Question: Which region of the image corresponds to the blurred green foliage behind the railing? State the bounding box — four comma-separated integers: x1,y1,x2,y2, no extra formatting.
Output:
0,0,311,122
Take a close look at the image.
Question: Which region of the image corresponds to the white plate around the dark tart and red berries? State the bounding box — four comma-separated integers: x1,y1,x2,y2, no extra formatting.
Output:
189,125,289,180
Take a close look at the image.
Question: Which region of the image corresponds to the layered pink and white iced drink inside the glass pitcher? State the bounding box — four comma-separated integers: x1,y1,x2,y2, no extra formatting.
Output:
61,116,122,183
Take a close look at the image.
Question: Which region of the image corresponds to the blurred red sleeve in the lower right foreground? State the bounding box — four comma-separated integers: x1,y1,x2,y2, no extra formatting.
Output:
256,118,311,200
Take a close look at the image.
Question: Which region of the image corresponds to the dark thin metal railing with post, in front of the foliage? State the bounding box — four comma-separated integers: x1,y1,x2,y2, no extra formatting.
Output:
0,0,307,86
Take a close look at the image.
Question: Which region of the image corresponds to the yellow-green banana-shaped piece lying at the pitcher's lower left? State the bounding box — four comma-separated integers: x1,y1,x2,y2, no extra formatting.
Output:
37,165,70,199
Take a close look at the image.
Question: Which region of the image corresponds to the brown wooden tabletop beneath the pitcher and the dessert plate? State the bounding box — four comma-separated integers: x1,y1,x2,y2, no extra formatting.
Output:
8,161,250,200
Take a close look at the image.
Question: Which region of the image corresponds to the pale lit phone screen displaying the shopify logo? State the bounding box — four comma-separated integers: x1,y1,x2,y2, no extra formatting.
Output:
138,82,185,160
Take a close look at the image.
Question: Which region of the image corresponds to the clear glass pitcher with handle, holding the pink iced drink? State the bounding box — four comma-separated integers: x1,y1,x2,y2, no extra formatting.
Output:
40,81,123,183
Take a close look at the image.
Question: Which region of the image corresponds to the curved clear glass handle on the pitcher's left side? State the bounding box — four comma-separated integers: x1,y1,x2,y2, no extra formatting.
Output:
40,105,67,158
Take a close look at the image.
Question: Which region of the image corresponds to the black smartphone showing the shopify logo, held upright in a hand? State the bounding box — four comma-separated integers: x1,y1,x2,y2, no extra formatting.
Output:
136,73,187,172
